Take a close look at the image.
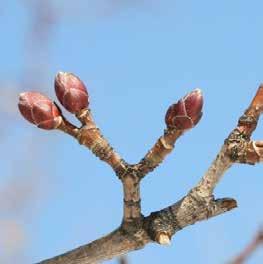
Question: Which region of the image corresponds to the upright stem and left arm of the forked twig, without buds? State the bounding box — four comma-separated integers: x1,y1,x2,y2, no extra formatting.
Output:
58,109,141,222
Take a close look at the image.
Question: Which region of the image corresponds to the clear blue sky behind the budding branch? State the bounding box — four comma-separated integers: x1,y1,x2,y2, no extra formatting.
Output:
0,0,263,264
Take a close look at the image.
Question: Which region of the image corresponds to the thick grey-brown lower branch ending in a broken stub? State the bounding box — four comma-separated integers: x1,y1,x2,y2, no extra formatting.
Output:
39,196,236,264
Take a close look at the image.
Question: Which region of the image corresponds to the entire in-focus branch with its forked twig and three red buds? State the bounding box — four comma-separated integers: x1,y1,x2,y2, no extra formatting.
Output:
18,75,263,264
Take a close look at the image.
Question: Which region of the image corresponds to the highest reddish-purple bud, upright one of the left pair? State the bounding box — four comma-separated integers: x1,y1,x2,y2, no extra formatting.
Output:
55,72,89,114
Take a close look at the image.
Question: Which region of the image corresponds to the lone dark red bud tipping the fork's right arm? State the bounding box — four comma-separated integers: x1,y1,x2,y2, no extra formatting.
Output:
165,89,203,130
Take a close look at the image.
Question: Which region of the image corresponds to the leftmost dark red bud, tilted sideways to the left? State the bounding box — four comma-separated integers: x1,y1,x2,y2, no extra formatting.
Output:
18,92,62,130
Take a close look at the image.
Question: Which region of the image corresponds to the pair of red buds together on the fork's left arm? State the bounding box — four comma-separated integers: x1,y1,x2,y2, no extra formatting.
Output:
18,72,89,130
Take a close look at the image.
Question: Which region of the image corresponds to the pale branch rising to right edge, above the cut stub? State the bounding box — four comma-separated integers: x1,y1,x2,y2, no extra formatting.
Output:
193,86,263,197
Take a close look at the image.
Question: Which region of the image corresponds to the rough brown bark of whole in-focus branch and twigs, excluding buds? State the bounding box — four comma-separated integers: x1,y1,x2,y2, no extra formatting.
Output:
36,87,263,264
